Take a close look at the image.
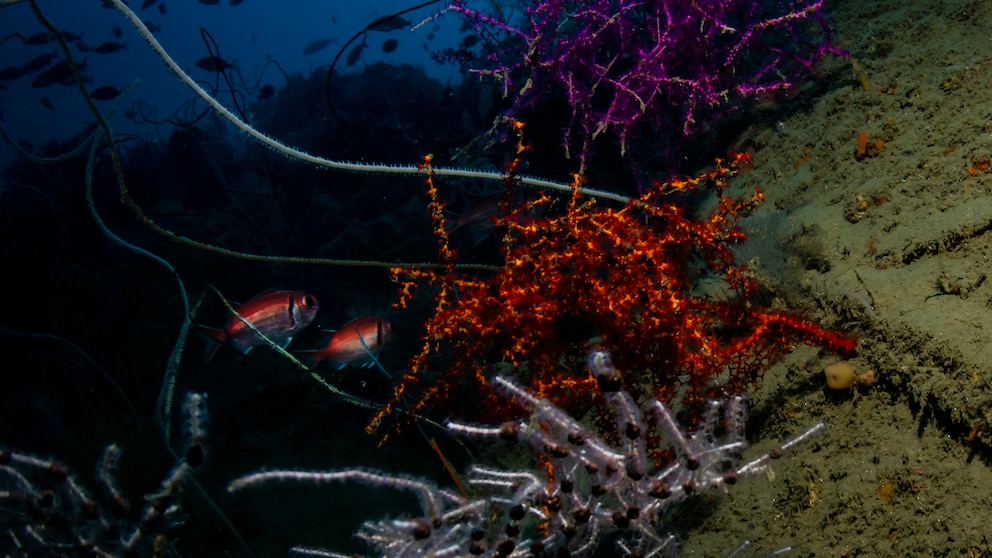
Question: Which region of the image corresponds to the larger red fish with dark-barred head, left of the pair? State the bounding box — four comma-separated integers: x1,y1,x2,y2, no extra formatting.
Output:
199,291,320,361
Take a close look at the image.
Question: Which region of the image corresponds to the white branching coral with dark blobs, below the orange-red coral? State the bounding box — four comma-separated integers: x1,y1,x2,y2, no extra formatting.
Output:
228,350,825,558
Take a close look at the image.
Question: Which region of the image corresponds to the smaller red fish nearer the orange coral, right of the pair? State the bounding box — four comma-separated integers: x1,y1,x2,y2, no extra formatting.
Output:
295,316,393,370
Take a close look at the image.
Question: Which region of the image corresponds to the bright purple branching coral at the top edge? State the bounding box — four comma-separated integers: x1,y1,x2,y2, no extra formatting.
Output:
451,0,840,171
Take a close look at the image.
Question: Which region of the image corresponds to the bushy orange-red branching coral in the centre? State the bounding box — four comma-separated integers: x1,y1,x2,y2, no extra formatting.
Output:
370,142,856,440
